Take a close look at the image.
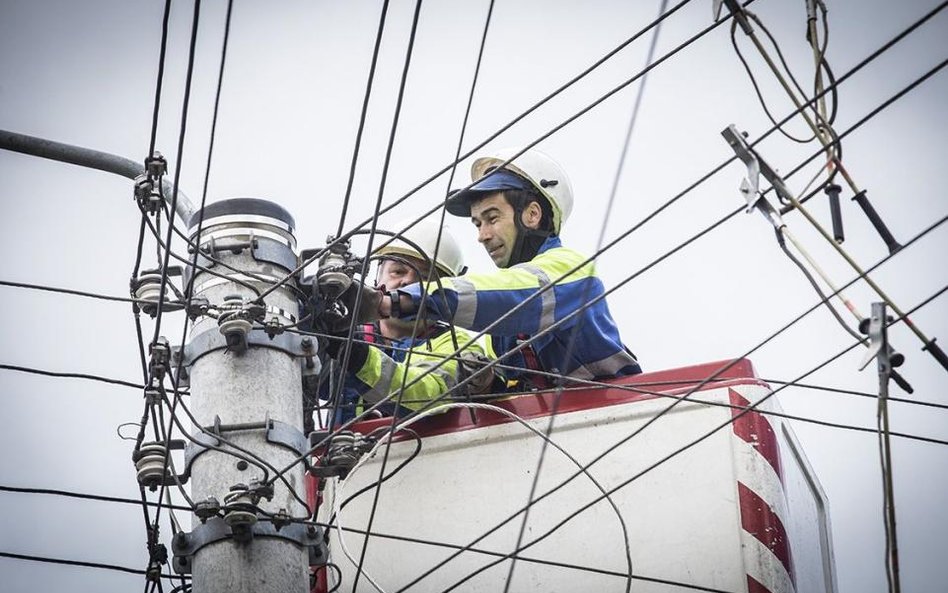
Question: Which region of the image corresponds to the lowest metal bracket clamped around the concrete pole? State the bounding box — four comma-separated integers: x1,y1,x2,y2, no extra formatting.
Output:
171,517,328,574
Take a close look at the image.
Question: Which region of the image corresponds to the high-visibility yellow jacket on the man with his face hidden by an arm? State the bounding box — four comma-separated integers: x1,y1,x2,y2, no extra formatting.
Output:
336,324,493,425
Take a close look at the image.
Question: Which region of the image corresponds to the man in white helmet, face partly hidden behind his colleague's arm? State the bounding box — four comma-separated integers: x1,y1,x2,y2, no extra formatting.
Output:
323,220,494,425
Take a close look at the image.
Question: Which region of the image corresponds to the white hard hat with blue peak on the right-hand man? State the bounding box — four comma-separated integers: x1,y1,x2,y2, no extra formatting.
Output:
448,148,573,234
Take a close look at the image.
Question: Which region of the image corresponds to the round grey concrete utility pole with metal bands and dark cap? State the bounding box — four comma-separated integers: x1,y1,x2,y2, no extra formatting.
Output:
172,198,325,593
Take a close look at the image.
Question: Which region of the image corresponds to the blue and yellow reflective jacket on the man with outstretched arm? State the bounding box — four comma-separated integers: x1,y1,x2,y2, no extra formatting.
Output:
399,237,642,379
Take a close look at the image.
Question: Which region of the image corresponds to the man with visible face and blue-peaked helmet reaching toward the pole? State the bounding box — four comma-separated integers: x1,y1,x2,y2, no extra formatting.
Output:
378,149,641,390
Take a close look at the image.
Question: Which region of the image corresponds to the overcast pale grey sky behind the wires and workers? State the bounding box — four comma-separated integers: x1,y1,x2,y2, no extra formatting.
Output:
0,0,948,592
